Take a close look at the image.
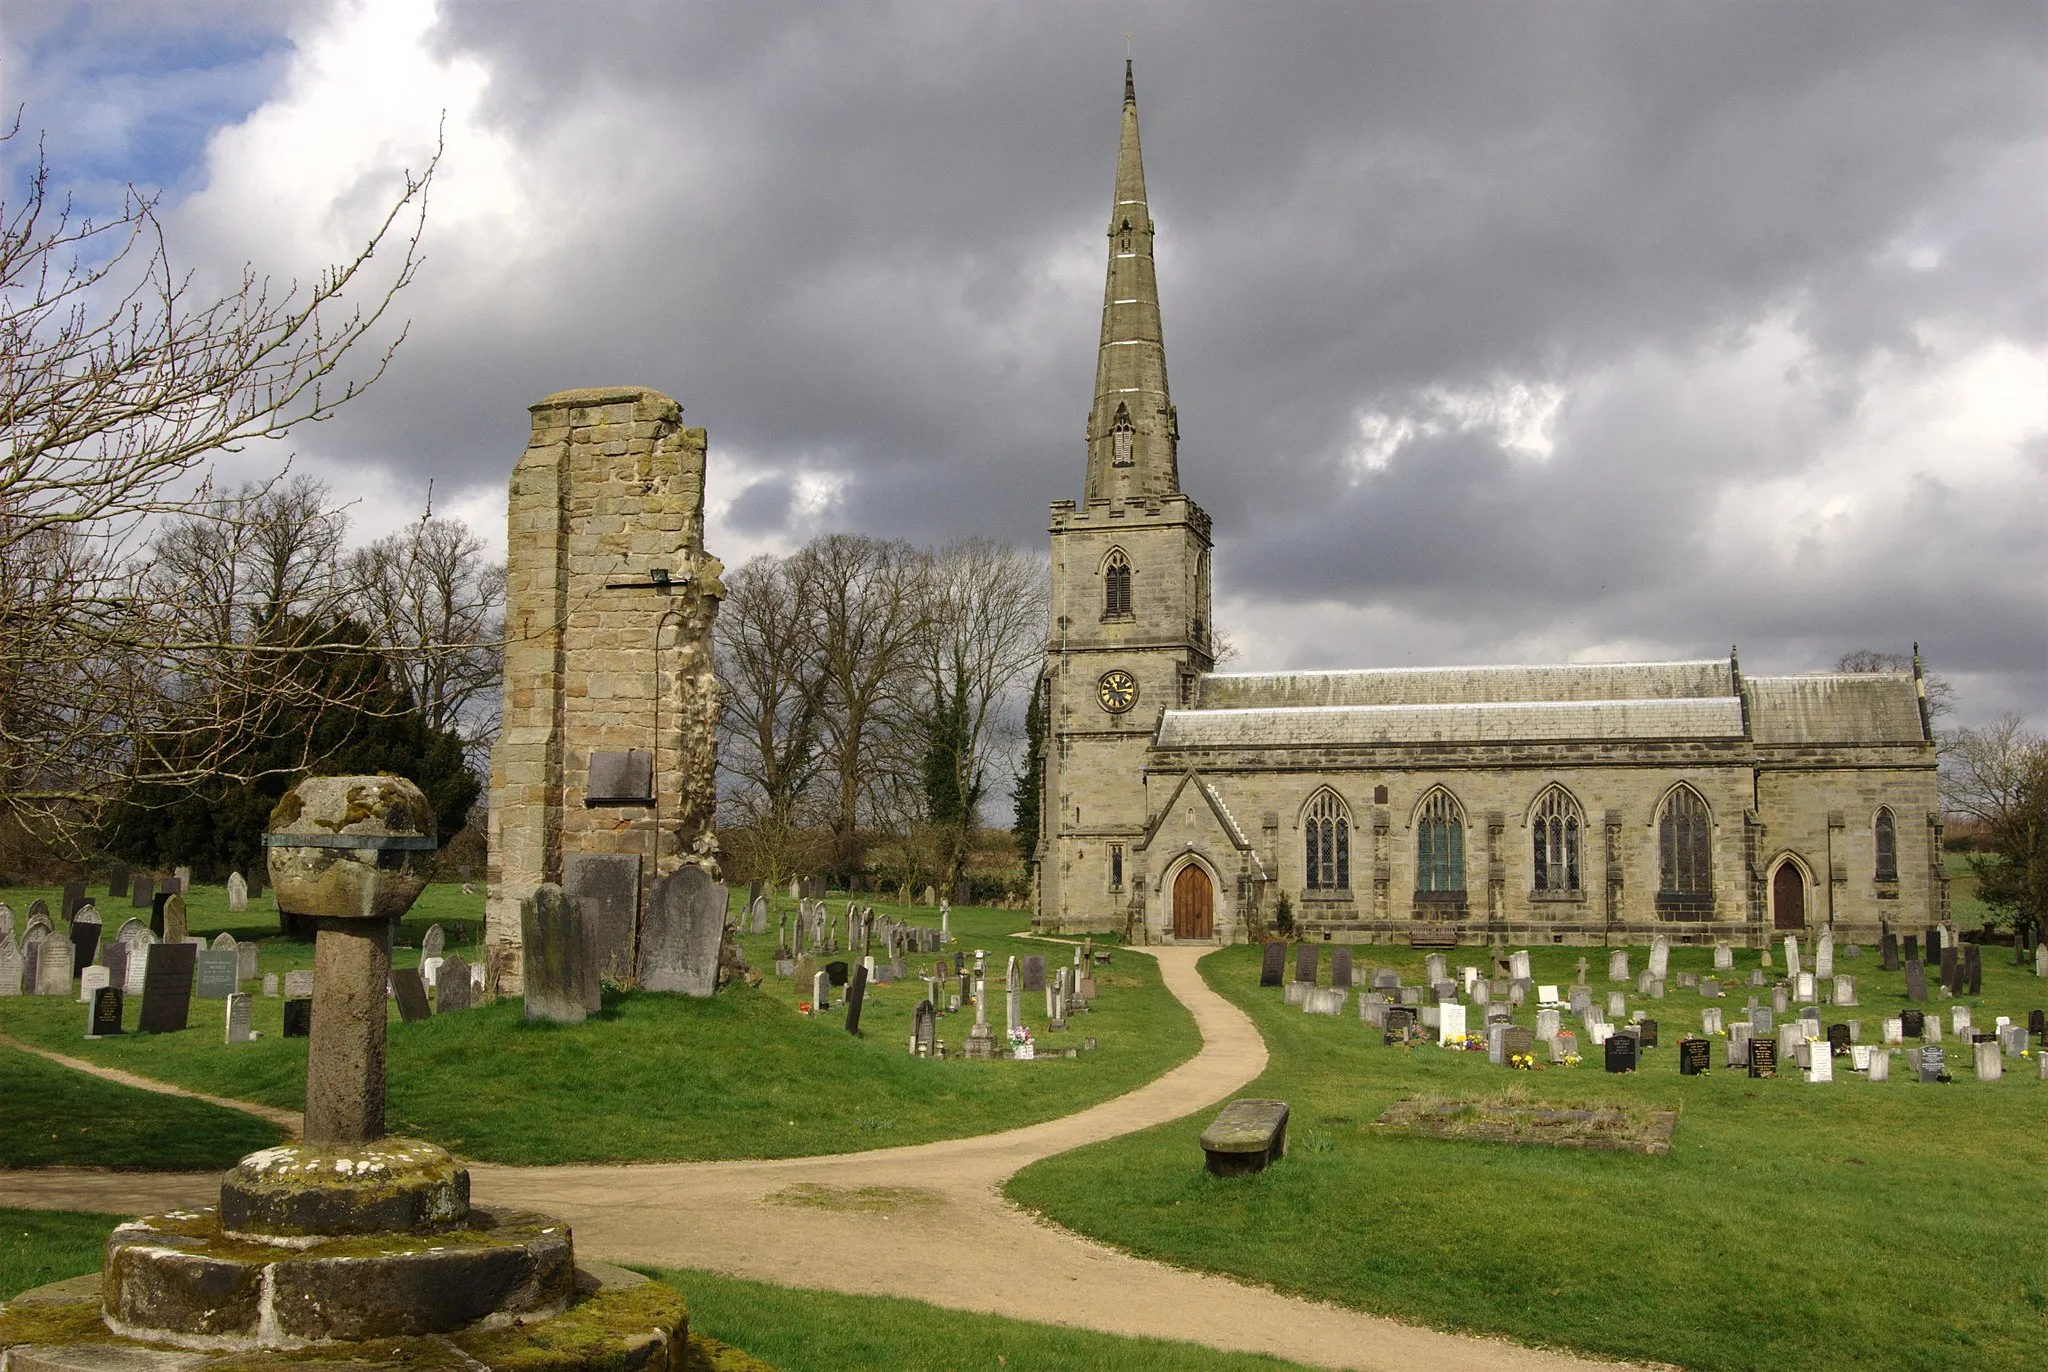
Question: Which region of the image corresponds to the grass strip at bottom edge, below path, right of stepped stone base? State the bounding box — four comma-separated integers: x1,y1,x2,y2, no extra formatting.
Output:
647,1268,1300,1372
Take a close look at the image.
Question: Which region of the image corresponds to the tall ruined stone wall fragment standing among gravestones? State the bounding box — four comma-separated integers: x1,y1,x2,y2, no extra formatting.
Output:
485,387,725,993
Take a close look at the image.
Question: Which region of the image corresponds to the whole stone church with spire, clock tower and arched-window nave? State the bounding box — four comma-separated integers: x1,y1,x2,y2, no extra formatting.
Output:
1034,63,1948,946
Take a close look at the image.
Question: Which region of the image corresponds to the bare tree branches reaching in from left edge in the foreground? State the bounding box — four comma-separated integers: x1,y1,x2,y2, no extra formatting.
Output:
0,123,438,854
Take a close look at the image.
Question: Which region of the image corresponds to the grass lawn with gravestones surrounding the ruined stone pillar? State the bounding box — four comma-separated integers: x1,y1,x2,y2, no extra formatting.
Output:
0,887,1200,1163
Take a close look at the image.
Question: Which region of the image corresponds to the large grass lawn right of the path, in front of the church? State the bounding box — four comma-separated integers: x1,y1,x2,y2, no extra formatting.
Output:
1010,946,2048,1370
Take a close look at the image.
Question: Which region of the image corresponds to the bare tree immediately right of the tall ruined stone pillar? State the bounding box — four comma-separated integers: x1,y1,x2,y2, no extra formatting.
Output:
717,555,825,883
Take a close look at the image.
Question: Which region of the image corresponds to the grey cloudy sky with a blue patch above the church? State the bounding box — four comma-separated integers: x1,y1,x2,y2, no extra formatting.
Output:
16,0,2048,725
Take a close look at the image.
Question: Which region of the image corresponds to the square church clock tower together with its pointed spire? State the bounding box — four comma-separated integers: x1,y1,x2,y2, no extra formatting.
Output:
1038,61,1214,930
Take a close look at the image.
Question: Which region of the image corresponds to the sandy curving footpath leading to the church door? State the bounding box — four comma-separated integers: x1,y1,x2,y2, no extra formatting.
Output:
0,948,1654,1372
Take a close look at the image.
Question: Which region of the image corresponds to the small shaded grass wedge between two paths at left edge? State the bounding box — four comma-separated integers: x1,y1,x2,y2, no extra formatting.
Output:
0,1056,285,1190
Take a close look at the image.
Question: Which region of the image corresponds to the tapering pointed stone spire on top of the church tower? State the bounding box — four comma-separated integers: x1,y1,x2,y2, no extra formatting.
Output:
1087,59,1180,500
